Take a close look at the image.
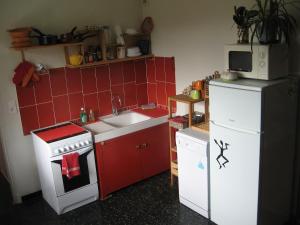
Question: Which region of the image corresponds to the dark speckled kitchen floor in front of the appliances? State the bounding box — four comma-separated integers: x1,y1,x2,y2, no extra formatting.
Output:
1,173,212,225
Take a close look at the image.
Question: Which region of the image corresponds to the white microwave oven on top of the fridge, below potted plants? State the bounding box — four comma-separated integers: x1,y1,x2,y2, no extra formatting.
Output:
224,44,288,80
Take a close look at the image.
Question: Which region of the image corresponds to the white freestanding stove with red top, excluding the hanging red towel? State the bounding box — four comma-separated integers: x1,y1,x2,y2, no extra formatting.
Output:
32,122,99,214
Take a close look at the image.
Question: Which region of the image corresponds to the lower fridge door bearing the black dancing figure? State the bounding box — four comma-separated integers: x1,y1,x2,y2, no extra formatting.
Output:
210,123,261,225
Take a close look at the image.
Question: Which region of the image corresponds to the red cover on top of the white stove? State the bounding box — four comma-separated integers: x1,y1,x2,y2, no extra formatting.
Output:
33,123,88,143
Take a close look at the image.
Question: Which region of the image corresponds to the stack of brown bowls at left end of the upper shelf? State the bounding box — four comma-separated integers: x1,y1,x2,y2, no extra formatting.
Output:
8,27,32,48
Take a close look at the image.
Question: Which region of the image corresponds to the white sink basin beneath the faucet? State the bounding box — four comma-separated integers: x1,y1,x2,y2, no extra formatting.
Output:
100,111,151,128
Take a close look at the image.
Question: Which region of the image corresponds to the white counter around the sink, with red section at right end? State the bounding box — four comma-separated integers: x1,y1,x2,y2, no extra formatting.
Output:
84,109,168,143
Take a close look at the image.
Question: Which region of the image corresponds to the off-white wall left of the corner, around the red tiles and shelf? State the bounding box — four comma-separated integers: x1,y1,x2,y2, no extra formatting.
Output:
0,0,142,202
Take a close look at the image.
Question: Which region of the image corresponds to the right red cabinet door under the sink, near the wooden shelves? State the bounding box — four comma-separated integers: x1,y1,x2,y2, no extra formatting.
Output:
139,123,170,178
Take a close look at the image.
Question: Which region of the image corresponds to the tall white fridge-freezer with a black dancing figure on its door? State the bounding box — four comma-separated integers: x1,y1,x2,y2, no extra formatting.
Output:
209,79,297,225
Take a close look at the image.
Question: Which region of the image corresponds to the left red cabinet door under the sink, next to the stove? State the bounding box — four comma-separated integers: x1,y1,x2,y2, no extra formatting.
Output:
97,133,142,198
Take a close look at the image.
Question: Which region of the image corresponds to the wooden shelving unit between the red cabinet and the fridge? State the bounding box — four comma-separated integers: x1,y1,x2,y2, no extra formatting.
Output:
168,94,204,186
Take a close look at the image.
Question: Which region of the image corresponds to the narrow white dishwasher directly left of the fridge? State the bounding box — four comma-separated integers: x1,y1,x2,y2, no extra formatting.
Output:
176,128,209,218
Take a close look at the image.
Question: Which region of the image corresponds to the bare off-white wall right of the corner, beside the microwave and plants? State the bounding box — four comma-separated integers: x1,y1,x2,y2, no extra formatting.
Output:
143,0,300,113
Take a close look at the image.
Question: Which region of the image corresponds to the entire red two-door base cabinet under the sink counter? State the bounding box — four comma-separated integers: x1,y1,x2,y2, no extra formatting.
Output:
96,123,170,199
